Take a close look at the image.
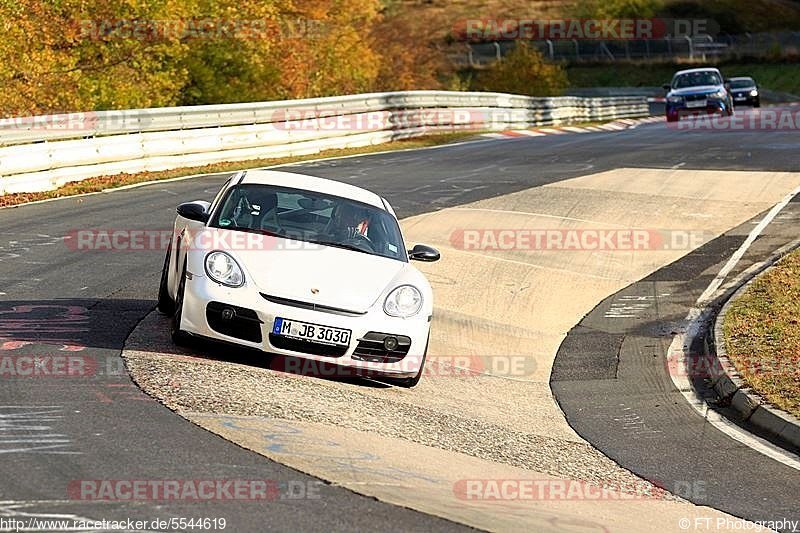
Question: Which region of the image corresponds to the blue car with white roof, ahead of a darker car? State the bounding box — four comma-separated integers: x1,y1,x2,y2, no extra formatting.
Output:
664,68,733,122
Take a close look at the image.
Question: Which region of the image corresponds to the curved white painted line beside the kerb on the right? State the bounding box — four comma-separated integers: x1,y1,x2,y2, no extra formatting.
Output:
667,183,800,470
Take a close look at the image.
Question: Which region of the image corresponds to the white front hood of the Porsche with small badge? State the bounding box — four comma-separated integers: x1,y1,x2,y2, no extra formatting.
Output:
231,233,413,312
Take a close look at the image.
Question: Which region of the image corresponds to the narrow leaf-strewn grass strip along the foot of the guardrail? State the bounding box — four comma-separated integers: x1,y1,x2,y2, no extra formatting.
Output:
0,131,480,207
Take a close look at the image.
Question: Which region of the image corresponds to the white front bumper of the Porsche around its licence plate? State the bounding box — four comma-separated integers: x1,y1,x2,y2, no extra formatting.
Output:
180,275,430,378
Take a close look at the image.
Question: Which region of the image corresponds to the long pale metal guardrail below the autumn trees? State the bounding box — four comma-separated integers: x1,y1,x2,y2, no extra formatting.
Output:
0,91,648,194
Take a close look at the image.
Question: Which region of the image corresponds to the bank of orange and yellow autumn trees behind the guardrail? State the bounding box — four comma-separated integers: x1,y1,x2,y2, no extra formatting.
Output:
0,0,454,116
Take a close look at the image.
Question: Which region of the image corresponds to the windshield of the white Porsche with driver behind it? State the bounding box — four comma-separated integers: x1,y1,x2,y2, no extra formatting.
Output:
209,184,408,262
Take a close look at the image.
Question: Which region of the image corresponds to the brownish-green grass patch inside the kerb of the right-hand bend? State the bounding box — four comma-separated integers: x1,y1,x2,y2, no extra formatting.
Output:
723,250,800,417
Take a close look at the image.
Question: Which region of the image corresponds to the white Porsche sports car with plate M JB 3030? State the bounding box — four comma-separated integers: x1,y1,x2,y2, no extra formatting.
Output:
158,170,439,387
